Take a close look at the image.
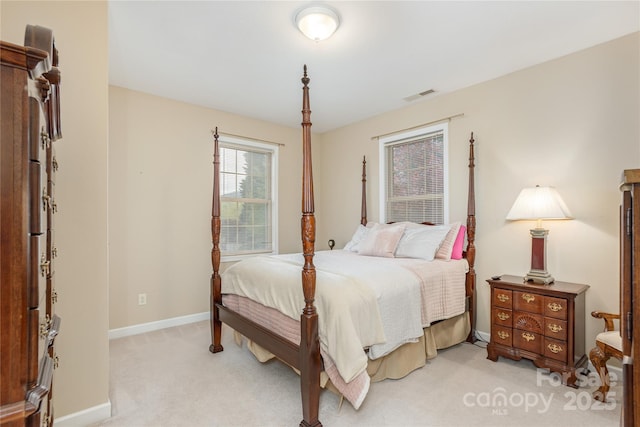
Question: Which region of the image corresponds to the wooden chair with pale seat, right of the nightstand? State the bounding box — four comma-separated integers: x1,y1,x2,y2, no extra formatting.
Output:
589,311,622,402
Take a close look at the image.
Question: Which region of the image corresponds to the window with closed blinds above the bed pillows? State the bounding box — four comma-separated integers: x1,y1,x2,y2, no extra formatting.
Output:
380,124,449,224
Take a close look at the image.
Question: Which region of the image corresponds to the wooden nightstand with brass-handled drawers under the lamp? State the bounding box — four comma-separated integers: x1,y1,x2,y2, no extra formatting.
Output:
487,276,589,388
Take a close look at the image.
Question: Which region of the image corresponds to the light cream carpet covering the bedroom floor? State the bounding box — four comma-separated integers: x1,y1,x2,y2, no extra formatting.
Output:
99,322,622,427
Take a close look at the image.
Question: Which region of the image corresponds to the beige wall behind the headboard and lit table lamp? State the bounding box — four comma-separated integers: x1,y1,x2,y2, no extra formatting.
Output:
316,33,640,351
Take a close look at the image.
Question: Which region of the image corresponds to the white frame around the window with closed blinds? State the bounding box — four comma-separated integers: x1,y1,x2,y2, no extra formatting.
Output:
378,122,449,224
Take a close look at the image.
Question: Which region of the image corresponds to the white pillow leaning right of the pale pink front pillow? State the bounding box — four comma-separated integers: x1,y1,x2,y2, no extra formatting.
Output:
396,225,452,261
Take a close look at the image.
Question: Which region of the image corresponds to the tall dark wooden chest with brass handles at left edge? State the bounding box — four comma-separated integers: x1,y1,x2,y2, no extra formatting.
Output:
0,26,61,427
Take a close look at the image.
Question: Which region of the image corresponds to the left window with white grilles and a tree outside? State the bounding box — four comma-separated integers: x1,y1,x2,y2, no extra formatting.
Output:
220,137,278,260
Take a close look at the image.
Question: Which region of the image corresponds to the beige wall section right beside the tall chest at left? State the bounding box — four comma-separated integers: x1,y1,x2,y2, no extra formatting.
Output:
0,1,109,417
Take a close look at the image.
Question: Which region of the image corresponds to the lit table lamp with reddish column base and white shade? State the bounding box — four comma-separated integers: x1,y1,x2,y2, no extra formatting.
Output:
507,185,571,285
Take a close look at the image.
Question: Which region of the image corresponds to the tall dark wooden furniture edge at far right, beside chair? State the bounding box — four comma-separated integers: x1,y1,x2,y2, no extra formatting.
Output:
620,169,640,427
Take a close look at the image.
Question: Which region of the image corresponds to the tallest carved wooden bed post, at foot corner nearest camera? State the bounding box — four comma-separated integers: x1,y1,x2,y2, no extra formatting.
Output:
300,65,322,427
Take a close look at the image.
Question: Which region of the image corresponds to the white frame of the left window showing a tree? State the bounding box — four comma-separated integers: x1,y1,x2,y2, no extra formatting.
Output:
218,135,280,262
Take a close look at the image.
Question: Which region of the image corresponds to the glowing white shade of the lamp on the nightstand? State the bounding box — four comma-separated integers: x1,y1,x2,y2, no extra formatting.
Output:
507,186,571,220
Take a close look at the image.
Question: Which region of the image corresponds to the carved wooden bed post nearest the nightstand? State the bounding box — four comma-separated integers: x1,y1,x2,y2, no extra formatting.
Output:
465,132,476,343
